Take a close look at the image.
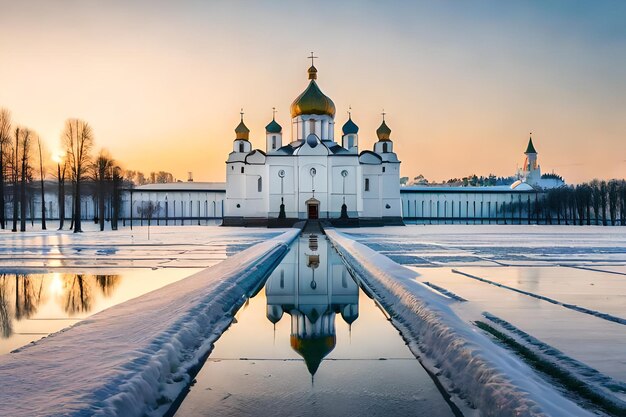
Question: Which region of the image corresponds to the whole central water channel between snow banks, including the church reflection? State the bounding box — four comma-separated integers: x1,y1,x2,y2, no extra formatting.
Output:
176,235,454,416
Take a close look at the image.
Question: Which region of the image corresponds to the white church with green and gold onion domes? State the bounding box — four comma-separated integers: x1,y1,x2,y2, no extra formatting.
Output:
223,58,402,226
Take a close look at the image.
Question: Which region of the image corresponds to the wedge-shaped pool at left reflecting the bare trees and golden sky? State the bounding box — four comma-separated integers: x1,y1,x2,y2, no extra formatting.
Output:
0,268,198,355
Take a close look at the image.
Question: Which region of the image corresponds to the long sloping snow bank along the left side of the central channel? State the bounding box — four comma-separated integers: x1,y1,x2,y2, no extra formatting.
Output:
0,229,299,417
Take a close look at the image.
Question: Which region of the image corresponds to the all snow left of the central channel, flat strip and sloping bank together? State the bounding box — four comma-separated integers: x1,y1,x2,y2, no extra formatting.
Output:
0,227,299,416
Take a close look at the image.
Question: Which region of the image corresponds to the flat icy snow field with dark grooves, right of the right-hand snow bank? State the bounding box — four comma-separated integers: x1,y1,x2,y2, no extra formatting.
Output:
332,225,626,413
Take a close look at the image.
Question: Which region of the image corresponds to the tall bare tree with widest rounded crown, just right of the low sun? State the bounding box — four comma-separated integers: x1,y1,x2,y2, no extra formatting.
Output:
61,119,93,233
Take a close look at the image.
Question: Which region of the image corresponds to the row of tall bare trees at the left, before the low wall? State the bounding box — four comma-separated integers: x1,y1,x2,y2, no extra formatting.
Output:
0,108,174,233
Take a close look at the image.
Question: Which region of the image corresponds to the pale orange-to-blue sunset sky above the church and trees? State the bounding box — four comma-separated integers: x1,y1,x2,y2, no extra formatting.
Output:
0,0,626,183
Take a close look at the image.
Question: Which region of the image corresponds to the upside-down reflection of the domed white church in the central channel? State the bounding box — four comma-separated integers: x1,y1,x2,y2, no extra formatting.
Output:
265,235,359,375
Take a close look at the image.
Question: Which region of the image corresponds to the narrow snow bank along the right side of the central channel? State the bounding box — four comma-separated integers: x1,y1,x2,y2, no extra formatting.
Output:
326,229,593,416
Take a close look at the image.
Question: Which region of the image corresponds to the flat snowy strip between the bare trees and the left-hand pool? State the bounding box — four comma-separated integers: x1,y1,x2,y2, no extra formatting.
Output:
0,223,279,272
